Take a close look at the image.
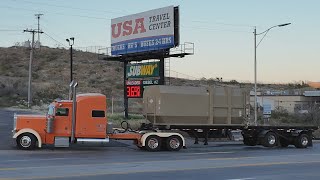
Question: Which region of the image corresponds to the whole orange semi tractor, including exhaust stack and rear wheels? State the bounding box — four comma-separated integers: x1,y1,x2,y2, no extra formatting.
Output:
12,82,185,151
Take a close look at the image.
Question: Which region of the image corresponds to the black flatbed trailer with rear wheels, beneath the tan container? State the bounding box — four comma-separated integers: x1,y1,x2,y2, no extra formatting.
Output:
149,124,318,148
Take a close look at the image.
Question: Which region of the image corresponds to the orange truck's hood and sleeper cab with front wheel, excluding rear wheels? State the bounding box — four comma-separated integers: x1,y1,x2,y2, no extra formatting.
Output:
13,93,109,149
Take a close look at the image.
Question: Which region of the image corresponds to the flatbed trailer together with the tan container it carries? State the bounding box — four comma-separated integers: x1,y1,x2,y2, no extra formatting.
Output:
143,85,318,148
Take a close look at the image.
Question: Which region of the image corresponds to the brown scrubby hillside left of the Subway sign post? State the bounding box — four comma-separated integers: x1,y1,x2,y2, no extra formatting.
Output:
0,47,123,107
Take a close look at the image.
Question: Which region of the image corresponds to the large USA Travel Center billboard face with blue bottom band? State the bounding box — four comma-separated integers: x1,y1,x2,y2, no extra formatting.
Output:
111,6,175,55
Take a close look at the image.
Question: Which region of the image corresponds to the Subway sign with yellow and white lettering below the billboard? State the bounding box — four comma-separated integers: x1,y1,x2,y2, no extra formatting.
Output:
126,62,160,79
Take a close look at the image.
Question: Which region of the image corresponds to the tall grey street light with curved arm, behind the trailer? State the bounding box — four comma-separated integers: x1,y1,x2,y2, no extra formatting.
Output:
253,23,291,126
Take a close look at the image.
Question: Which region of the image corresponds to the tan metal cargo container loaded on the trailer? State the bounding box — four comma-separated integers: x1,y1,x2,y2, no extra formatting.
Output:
143,86,249,125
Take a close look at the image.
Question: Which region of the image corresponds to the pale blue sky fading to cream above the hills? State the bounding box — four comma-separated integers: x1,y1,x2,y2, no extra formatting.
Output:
0,0,320,83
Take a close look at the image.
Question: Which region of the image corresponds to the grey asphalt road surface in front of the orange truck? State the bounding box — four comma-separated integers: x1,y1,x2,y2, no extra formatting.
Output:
0,107,320,180
